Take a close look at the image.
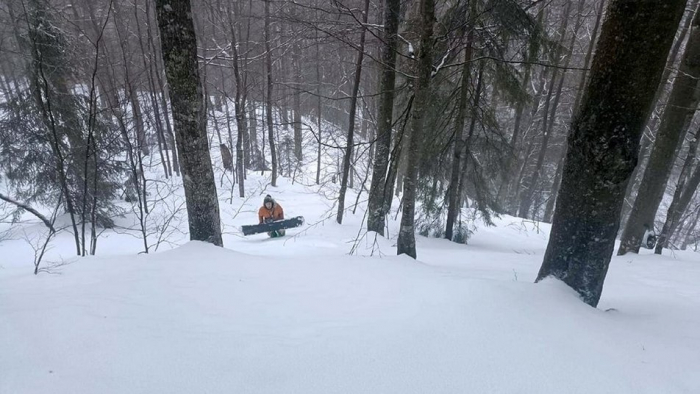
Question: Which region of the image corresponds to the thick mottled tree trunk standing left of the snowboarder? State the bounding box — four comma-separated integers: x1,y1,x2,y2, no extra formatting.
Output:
156,0,223,246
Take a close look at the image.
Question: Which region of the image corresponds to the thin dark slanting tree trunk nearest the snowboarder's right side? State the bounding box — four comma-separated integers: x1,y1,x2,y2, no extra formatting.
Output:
336,0,369,224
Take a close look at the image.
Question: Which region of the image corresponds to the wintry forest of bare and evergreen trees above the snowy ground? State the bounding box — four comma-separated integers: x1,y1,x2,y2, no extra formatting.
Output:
0,0,700,305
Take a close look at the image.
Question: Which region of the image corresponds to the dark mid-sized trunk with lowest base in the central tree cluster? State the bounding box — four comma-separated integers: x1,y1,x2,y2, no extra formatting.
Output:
396,0,435,259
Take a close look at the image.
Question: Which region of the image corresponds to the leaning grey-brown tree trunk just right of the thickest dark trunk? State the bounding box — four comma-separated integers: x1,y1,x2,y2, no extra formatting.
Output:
617,10,700,255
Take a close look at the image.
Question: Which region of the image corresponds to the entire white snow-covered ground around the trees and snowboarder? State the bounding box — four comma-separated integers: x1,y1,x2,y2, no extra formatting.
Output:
0,110,700,394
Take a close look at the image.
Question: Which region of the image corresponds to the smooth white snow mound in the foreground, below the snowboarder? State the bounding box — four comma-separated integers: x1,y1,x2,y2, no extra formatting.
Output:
0,240,700,394
